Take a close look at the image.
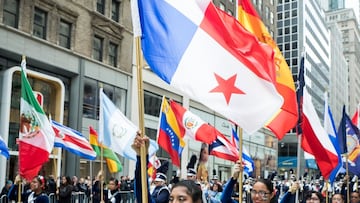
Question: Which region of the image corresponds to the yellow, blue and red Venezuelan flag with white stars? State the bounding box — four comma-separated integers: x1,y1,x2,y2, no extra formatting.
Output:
157,97,185,167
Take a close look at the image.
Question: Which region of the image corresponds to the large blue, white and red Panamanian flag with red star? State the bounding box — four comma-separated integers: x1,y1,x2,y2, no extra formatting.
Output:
132,0,283,133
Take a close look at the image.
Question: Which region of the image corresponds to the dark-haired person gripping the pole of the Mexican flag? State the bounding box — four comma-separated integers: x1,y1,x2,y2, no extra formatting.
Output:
8,175,50,203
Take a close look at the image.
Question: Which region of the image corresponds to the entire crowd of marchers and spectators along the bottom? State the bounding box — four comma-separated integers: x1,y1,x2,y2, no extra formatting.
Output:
1,131,360,203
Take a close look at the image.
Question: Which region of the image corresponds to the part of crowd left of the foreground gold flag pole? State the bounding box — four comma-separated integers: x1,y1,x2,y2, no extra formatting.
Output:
0,171,134,203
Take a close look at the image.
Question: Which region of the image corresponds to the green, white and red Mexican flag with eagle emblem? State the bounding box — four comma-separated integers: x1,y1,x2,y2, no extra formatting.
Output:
19,59,55,180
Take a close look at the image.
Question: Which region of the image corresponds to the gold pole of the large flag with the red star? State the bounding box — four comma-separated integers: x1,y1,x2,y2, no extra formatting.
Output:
135,37,148,203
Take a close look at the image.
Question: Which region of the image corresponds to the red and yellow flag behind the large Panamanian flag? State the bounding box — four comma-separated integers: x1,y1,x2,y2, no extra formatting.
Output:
238,0,298,139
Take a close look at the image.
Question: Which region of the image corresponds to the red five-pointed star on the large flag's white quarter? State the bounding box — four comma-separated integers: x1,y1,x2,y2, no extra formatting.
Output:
210,73,245,104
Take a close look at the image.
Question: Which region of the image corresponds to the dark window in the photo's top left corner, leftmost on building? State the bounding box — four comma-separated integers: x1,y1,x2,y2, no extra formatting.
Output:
3,0,19,28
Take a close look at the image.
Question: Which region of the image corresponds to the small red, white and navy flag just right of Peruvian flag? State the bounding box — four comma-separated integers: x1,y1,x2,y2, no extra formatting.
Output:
209,133,239,162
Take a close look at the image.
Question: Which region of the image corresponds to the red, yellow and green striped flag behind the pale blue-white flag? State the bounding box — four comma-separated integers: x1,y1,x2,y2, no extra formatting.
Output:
89,126,122,173
